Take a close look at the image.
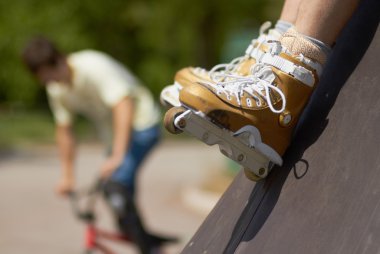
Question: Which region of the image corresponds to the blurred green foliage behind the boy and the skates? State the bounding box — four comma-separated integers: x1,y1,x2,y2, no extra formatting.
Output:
0,0,283,109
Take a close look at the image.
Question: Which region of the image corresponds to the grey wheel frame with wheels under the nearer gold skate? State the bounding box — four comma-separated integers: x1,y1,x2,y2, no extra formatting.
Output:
165,107,282,181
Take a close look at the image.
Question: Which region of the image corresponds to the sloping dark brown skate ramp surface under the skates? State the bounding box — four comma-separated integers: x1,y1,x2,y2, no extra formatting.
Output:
182,0,380,254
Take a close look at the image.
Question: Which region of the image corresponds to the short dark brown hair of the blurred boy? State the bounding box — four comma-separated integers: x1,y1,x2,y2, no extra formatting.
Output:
22,36,63,73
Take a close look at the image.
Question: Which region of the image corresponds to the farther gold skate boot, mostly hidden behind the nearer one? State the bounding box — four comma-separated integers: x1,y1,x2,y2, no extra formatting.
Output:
160,22,280,108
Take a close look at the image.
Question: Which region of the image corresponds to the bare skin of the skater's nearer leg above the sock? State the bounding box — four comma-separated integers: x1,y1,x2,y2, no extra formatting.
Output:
294,0,360,46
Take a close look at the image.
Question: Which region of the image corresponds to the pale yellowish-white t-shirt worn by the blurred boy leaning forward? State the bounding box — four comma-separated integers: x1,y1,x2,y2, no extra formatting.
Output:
46,50,160,143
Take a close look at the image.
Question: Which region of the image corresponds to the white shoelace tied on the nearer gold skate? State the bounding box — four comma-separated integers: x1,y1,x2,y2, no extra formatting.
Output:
207,63,286,113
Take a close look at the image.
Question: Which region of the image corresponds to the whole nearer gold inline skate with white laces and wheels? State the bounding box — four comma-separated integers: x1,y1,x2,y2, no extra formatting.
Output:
165,30,325,180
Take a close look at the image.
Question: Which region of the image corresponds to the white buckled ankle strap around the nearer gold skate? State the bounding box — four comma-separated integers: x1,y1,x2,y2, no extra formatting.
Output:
251,48,322,87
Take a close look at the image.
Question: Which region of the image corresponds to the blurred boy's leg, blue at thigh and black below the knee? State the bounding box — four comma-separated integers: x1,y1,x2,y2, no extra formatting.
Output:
104,126,165,254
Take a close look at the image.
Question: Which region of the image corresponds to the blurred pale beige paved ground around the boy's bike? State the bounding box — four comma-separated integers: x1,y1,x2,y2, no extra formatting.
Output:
0,140,232,254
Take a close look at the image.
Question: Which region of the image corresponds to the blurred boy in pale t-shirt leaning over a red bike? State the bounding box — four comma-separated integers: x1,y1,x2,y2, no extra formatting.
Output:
22,37,174,253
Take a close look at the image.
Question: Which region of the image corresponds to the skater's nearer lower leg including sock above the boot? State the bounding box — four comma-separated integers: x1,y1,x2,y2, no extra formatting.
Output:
281,0,360,66
